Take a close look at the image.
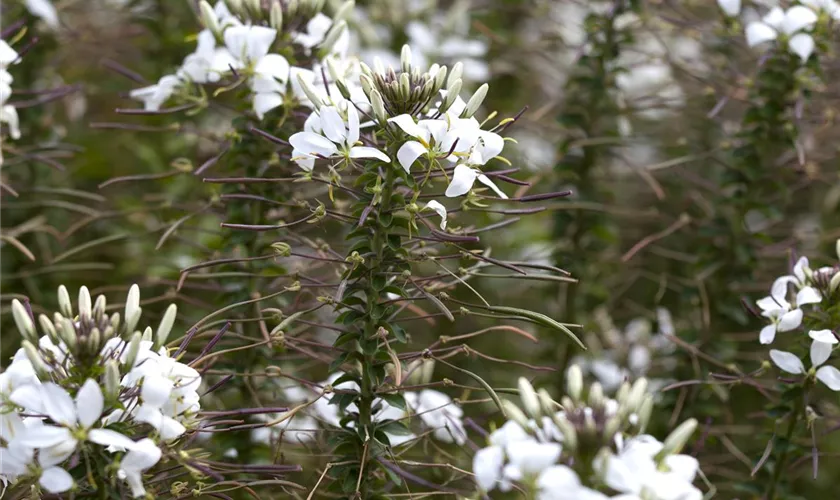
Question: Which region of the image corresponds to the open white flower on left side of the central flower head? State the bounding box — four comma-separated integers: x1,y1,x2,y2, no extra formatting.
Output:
289,101,391,163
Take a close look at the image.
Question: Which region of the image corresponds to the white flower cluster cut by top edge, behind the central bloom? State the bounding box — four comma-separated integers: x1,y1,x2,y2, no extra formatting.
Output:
130,0,352,118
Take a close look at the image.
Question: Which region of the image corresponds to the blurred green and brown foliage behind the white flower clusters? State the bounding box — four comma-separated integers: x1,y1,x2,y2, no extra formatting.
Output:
0,0,840,498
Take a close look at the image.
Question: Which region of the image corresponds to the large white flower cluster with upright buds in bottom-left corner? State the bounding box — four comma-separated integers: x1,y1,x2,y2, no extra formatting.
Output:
0,285,201,498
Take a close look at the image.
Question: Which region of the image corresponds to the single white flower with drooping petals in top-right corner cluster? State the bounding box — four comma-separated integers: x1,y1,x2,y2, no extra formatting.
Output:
746,5,817,62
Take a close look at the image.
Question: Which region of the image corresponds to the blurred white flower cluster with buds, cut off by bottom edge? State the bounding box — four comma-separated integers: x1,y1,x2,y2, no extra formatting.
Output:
473,365,703,500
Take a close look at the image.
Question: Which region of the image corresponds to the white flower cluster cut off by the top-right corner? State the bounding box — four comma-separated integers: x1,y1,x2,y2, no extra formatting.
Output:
718,0,840,63
